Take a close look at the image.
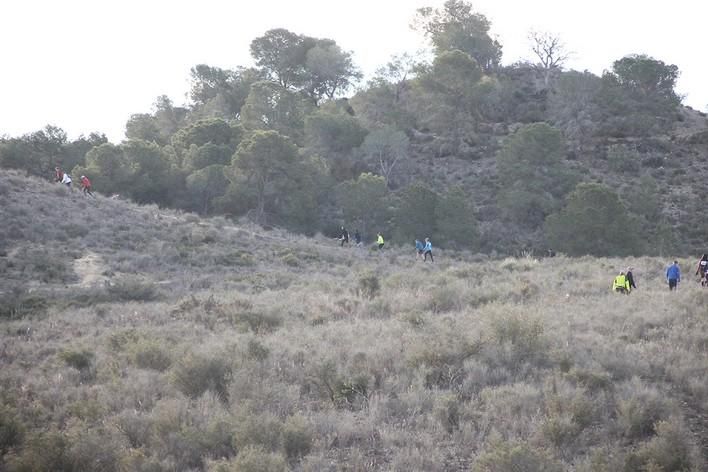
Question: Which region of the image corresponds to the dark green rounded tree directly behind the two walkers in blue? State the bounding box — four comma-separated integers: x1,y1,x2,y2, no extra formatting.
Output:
394,182,438,242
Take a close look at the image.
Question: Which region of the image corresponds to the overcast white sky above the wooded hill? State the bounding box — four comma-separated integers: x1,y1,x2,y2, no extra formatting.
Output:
0,0,708,142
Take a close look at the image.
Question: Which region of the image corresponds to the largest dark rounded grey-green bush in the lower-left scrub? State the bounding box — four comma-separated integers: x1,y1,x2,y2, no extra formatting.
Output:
172,354,231,402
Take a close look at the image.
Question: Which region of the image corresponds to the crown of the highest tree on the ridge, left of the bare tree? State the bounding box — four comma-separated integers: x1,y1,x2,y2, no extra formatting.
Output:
417,0,502,71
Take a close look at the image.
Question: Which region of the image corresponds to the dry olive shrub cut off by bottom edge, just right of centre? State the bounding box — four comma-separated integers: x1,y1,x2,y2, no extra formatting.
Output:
472,441,563,472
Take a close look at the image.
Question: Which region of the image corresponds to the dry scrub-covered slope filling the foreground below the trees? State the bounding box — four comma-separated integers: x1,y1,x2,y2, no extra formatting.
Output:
0,173,708,471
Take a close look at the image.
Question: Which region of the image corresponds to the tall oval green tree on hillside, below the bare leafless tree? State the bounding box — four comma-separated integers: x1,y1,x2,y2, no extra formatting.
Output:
497,123,574,229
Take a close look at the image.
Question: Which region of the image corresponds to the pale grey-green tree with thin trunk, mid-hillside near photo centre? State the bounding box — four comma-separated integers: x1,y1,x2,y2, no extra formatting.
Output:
361,127,410,185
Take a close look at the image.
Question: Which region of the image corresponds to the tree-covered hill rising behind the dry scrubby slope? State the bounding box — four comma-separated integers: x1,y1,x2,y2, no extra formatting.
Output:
0,0,696,255
